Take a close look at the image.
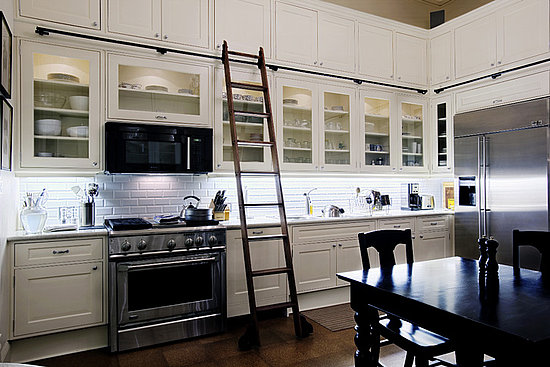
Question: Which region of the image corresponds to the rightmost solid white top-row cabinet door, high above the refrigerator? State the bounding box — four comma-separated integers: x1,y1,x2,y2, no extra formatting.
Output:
497,0,550,65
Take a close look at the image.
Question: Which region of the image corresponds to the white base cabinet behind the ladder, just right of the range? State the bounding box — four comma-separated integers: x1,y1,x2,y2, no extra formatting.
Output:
227,227,287,317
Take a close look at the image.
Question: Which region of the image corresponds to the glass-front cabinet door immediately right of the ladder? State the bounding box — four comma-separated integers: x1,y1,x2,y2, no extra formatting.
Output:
277,79,320,170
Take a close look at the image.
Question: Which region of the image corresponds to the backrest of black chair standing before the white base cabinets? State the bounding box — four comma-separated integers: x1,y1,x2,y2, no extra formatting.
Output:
358,229,414,269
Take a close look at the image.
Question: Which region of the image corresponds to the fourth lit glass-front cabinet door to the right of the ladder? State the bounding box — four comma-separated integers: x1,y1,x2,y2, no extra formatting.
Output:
398,96,428,172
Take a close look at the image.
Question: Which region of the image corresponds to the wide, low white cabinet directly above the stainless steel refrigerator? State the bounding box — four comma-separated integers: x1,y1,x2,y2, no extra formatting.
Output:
456,71,550,113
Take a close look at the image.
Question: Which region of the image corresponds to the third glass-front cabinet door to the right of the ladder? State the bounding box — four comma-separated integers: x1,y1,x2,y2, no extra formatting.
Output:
360,91,395,171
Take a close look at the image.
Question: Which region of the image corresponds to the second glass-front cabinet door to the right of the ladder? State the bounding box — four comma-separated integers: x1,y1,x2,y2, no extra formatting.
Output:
320,86,356,171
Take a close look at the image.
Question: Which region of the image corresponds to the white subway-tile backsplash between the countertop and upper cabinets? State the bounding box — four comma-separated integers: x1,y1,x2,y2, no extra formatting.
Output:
19,174,450,225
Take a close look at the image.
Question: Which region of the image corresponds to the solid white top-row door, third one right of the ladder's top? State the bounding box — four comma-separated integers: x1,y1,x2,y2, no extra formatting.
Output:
357,23,393,80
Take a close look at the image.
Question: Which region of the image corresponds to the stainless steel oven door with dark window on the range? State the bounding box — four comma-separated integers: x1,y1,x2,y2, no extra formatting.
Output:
116,252,225,325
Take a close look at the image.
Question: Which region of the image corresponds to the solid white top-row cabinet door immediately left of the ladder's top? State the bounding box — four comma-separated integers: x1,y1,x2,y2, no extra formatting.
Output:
162,0,210,48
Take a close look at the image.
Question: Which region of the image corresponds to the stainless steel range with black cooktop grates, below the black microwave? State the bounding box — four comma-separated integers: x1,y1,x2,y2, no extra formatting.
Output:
106,218,226,352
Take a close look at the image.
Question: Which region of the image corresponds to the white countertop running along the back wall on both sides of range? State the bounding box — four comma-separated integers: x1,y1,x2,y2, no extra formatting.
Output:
8,209,454,242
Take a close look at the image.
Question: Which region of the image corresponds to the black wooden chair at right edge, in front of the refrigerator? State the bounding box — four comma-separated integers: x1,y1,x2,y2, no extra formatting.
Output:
512,229,550,278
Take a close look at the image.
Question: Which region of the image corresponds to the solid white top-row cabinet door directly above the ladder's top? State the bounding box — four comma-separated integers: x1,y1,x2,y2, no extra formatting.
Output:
215,0,271,58
